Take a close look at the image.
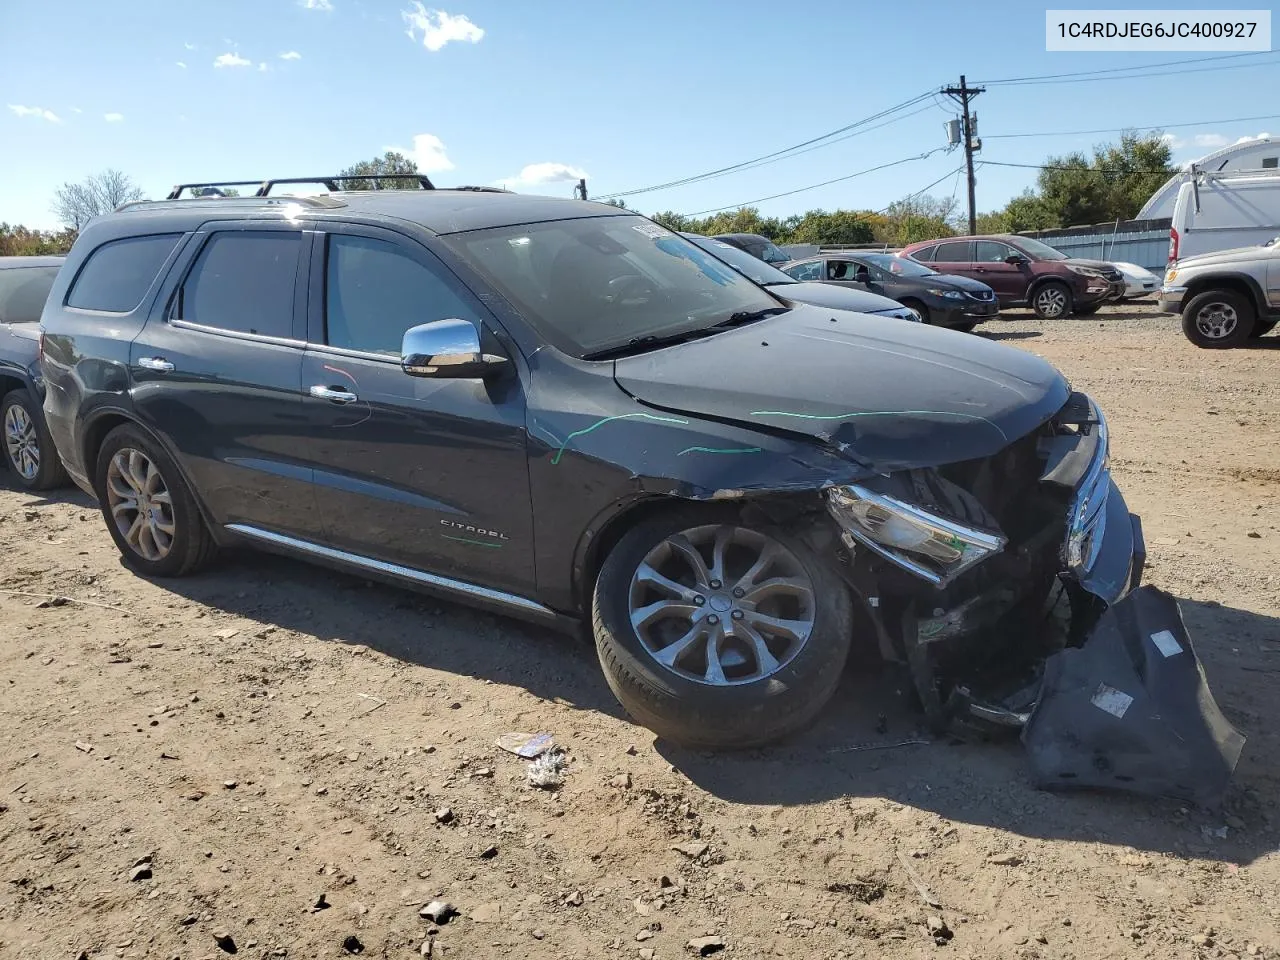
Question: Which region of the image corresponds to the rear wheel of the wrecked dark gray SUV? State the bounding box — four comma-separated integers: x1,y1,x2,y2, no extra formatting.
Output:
93,424,216,577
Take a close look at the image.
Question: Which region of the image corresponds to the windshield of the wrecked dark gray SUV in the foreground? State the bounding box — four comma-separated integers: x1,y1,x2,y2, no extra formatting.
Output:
440,216,783,357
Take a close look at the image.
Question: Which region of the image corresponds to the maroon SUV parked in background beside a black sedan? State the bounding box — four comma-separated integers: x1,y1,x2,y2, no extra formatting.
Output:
901,234,1125,320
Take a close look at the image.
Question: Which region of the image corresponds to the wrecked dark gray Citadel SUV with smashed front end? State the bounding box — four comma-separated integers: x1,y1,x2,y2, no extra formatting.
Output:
42,176,1162,746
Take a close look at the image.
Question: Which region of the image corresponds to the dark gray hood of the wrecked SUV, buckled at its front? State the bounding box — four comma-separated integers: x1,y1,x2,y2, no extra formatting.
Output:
614,306,1070,471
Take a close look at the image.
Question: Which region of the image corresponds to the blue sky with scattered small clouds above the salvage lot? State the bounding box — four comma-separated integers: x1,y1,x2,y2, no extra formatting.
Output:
0,0,1280,228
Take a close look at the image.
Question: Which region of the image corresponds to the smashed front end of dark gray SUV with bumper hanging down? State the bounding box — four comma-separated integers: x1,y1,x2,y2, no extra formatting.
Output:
827,393,1243,804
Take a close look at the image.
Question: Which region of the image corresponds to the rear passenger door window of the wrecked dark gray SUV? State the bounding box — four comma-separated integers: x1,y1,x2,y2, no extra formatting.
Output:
178,230,302,337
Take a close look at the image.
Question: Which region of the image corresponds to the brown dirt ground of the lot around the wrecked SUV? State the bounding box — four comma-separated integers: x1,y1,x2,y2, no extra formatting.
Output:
0,307,1280,960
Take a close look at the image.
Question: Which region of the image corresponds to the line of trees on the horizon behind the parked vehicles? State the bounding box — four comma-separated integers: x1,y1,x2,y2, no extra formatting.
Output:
0,132,1175,256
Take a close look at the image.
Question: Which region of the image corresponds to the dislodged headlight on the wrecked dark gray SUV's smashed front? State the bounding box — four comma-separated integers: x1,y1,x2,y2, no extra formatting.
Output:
827,484,1007,588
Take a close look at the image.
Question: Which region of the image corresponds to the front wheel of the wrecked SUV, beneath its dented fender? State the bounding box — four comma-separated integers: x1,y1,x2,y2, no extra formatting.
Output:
593,509,852,748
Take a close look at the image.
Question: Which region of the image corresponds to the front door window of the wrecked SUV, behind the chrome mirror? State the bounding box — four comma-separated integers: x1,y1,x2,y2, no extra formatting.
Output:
325,234,475,357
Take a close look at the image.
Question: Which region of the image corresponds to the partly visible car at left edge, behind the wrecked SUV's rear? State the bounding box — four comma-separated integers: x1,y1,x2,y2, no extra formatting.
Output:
0,257,67,490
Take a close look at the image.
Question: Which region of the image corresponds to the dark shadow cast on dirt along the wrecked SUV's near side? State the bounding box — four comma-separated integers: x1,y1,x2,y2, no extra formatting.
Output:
104,553,1280,863
